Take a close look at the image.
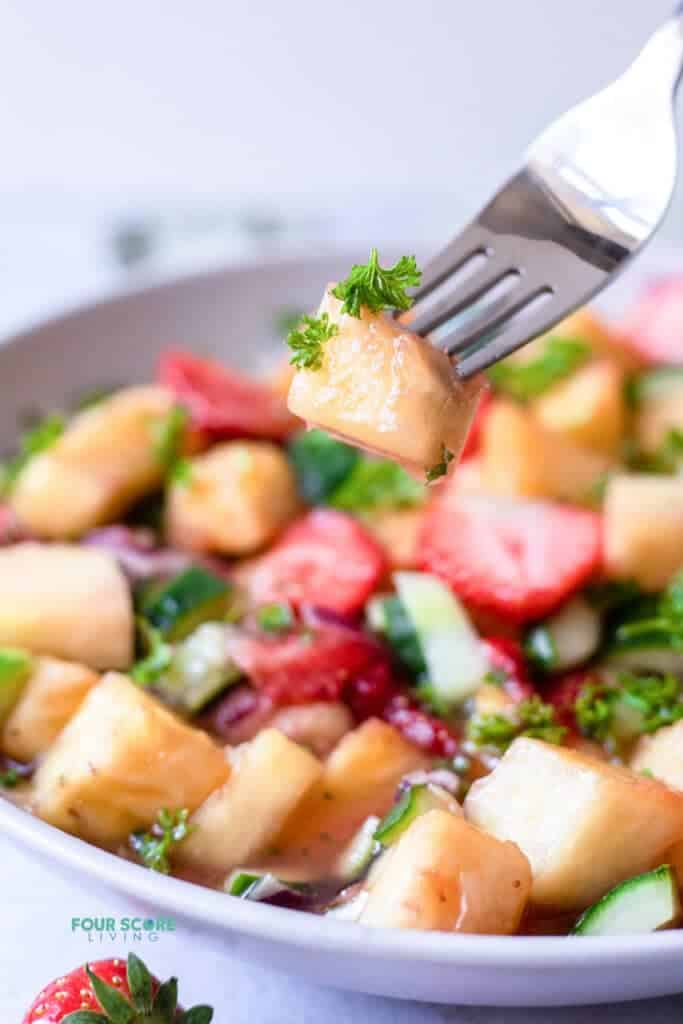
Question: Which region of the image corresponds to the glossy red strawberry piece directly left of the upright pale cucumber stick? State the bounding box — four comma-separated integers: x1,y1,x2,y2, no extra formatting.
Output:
228,626,386,705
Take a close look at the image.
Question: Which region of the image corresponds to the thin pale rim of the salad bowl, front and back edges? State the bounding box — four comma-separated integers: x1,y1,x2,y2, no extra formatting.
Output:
0,247,683,971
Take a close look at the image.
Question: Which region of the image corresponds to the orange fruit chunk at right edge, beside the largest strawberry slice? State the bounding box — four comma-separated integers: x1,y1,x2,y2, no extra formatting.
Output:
604,473,683,591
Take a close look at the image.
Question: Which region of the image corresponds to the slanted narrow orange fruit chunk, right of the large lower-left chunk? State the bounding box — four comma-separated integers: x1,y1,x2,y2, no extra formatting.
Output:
178,729,323,871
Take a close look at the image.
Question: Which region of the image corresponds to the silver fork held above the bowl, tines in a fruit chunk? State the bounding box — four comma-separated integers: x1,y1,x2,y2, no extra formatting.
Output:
410,3,683,378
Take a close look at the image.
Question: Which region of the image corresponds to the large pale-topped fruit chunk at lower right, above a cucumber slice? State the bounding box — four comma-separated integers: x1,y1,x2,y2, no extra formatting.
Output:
465,738,683,910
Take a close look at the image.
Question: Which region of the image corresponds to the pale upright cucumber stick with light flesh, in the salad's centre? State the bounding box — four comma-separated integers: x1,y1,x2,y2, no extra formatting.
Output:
393,572,488,707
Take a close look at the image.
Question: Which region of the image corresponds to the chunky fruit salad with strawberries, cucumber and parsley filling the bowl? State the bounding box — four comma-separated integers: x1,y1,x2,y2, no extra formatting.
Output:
0,251,683,937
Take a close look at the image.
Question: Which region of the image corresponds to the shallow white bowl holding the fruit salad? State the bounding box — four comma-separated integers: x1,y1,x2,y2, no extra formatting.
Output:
0,251,683,1006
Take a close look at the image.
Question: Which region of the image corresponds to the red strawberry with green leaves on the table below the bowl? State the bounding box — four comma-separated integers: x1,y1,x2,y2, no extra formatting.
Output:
23,953,213,1024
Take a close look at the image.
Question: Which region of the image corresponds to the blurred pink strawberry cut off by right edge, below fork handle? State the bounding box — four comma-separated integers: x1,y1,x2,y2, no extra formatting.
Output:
620,273,683,366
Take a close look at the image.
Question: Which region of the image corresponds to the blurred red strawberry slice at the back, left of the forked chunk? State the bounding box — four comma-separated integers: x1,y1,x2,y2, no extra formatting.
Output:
159,351,301,440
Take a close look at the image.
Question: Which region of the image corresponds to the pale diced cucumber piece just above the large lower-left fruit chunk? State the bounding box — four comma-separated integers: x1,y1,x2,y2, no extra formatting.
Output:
154,623,241,714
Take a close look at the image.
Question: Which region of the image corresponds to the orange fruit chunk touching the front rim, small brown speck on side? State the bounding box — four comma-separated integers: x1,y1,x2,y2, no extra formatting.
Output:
358,810,531,935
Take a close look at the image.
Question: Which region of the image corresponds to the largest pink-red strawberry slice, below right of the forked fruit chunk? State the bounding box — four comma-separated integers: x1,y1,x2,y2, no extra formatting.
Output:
420,492,601,623
